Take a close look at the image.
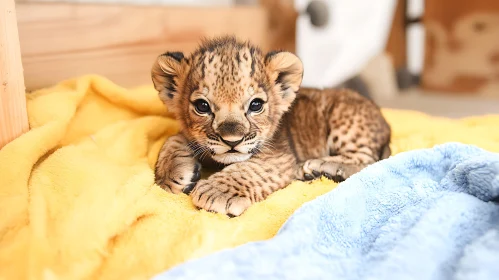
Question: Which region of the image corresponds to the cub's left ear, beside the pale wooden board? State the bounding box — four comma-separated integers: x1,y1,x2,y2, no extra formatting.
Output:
151,52,188,104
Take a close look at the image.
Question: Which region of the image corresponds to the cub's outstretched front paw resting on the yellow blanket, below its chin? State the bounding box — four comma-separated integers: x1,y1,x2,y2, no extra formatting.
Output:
190,179,251,217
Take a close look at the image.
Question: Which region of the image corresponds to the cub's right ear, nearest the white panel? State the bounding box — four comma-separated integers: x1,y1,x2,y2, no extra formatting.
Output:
265,51,303,104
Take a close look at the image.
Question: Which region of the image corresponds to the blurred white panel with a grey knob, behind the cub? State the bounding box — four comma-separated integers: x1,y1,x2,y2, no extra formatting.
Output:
295,0,396,87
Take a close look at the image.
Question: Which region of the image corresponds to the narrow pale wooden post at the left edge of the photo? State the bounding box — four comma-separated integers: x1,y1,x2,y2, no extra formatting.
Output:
0,0,29,149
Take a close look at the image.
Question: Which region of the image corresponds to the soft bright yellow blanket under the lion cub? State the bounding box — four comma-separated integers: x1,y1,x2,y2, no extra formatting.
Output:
0,76,499,279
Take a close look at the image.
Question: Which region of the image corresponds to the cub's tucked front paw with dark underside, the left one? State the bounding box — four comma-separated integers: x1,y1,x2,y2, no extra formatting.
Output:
154,156,201,194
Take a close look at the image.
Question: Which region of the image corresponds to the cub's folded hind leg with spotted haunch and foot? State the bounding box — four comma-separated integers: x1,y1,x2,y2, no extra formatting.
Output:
297,88,391,182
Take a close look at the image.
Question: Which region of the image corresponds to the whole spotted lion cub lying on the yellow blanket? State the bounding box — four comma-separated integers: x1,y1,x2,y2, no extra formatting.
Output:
152,36,391,216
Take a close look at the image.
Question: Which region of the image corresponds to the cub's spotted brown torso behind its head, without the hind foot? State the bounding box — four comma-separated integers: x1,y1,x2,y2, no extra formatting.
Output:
282,88,390,162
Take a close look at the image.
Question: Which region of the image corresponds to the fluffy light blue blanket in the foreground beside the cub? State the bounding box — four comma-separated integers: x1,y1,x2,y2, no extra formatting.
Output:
155,143,499,280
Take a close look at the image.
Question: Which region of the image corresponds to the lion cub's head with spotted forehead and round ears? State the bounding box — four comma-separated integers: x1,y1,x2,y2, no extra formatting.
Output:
152,37,303,164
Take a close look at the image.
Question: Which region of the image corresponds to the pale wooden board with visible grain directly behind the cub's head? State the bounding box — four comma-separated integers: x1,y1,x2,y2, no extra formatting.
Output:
18,3,268,90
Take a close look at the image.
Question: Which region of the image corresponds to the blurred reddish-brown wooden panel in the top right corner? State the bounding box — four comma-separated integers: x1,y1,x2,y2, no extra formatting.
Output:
422,0,499,98
